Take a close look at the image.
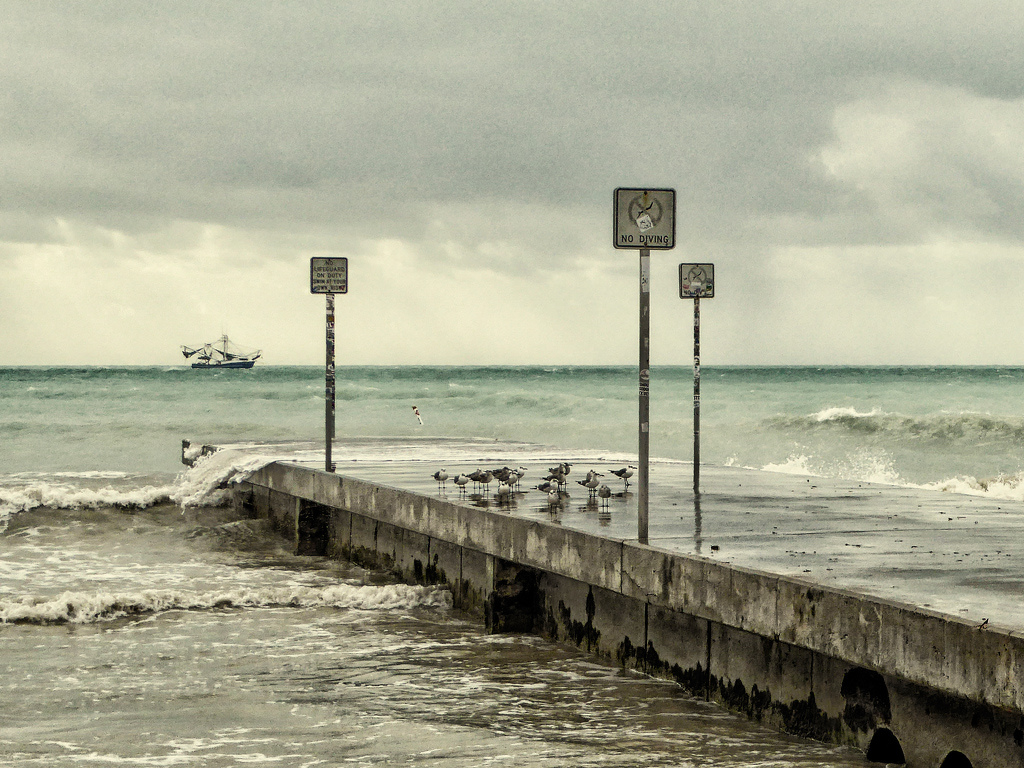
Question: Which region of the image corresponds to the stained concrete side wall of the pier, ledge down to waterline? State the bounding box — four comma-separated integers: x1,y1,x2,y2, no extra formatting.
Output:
237,464,1024,768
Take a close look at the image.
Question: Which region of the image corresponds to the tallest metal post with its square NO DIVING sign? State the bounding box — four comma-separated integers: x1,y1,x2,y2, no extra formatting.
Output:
612,187,676,544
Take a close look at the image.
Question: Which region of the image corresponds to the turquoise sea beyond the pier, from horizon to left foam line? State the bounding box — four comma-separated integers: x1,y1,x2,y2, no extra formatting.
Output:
8,367,1024,503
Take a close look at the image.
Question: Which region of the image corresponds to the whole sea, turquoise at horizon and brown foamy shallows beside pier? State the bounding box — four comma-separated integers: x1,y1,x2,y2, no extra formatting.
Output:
8,367,1024,767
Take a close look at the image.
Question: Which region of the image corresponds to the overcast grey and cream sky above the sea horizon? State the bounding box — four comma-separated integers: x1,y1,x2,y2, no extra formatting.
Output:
0,0,1024,366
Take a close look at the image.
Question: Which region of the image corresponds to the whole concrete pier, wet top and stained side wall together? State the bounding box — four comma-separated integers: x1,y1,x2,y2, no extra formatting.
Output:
188,438,1024,768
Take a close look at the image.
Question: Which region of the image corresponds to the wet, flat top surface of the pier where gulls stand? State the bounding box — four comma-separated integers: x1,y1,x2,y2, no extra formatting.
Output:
216,439,1024,631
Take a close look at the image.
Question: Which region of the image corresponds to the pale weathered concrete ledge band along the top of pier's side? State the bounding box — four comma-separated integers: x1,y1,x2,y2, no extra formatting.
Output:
247,456,1024,713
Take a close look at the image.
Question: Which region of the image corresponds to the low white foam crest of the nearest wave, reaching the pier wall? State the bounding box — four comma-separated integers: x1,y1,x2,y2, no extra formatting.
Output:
0,584,452,624
